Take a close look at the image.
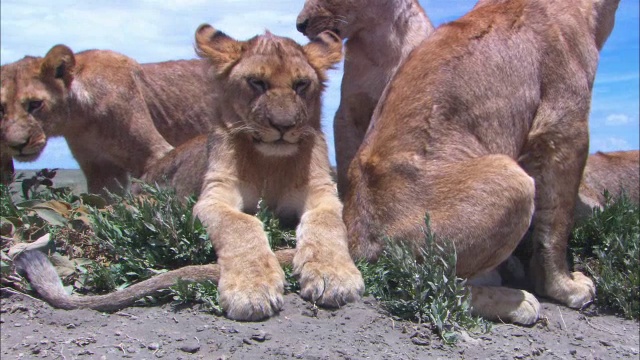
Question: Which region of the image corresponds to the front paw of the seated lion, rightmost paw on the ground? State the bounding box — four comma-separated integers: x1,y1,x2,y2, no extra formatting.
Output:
547,271,596,309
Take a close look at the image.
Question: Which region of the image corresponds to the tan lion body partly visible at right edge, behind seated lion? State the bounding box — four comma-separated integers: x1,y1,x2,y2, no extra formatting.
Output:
575,150,640,221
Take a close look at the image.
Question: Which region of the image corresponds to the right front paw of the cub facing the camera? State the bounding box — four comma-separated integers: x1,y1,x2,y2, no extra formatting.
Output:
298,259,364,307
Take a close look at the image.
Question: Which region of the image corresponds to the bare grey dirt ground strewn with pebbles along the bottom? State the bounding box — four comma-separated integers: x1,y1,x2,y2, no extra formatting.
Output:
0,290,640,360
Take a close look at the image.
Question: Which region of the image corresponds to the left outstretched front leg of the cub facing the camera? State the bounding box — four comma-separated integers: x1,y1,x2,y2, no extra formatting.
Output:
193,183,284,321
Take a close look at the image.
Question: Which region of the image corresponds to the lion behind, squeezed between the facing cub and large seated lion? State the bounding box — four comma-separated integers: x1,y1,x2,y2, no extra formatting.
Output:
297,0,433,197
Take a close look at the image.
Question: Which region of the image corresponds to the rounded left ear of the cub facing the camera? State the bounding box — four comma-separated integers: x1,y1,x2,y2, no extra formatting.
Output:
196,24,243,75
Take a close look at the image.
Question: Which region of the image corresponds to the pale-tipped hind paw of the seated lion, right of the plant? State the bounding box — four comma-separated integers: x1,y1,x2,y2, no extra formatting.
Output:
471,286,540,325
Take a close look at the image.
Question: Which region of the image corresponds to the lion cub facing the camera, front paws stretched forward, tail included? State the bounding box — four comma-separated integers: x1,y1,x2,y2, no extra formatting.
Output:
16,25,364,320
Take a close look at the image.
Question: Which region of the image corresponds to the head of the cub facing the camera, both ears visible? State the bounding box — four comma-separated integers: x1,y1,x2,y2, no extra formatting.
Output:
196,25,342,156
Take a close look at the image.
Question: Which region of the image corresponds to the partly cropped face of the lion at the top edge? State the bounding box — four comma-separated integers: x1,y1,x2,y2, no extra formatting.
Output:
296,0,364,39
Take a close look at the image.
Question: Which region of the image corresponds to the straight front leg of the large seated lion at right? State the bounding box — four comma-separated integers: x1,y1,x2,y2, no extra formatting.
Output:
524,125,596,308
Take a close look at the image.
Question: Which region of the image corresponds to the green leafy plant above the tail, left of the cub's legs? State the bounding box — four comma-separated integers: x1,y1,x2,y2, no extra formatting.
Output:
88,184,216,290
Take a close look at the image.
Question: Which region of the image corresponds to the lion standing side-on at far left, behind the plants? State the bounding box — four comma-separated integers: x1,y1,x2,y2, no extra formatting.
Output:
0,45,216,192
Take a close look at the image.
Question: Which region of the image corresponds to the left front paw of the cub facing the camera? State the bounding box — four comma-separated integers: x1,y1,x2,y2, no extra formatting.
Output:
218,258,284,321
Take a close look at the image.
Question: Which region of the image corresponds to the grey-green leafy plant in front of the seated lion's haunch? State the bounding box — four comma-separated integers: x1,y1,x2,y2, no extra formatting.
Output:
357,217,489,343
